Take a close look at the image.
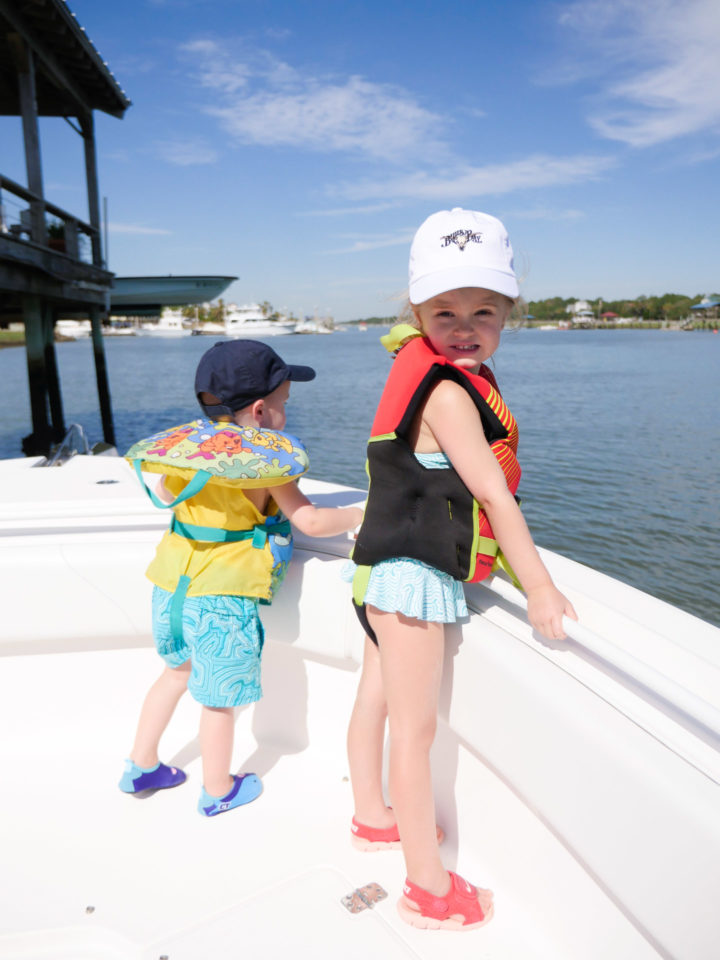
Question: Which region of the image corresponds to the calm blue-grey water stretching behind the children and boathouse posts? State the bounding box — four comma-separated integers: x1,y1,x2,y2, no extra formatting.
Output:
0,328,720,625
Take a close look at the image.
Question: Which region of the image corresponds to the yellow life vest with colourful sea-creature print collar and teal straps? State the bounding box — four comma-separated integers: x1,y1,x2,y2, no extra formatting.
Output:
125,419,309,630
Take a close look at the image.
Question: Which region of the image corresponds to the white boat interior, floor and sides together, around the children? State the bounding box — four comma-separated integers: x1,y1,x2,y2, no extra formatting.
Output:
0,457,720,960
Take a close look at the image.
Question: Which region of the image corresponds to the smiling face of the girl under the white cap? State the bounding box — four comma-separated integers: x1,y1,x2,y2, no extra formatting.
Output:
412,287,512,373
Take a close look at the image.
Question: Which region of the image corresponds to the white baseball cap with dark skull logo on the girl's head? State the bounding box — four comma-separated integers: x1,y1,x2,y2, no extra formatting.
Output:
410,207,520,304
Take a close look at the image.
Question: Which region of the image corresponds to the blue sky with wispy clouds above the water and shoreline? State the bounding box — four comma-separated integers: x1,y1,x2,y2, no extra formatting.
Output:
0,0,720,320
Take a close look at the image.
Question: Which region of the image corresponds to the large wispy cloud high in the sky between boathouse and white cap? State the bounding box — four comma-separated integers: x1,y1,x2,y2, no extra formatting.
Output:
182,40,444,161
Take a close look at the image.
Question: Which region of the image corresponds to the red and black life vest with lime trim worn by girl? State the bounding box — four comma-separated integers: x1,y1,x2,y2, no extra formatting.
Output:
353,325,521,602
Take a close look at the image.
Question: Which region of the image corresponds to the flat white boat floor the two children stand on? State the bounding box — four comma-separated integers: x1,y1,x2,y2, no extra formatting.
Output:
0,645,656,960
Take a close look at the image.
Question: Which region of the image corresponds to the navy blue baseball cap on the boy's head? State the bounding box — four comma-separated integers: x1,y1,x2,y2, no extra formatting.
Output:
195,340,315,417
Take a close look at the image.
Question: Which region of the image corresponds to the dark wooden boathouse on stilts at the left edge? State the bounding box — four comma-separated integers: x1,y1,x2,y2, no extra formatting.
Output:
0,0,130,455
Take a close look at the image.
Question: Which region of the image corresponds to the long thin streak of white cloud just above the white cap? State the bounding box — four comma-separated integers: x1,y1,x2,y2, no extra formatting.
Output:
332,155,615,203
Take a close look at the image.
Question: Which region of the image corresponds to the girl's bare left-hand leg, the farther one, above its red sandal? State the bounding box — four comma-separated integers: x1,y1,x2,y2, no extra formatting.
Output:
347,637,395,829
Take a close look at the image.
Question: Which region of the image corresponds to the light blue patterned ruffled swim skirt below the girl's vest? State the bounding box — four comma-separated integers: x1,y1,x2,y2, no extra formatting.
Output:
341,557,468,623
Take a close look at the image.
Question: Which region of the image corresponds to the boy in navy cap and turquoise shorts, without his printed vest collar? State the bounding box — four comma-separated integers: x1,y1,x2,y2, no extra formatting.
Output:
119,340,362,817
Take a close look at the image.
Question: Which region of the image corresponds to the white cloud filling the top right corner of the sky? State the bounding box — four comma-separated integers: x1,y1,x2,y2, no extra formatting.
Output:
560,0,720,147
